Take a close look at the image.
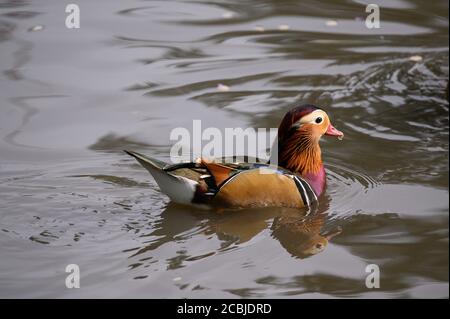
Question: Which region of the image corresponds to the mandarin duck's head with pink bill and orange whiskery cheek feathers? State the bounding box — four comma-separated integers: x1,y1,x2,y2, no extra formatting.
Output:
278,104,344,174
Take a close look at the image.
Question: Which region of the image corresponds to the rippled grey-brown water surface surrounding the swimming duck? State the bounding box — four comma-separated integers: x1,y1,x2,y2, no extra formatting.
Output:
0,0,449,298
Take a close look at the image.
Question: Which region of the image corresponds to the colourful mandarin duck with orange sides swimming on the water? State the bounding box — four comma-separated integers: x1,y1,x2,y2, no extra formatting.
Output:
124,104,344,209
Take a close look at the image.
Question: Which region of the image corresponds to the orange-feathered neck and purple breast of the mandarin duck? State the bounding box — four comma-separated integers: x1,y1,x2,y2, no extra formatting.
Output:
278,134,325,196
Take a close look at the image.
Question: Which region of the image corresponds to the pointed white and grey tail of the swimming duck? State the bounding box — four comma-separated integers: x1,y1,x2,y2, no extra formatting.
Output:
124,150,198,204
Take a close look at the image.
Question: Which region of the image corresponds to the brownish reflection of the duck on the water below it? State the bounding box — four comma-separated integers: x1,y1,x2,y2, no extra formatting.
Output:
126,194,341,261
